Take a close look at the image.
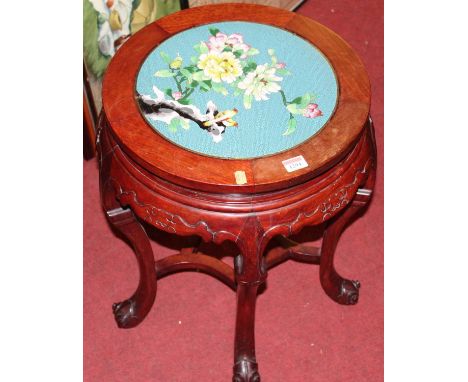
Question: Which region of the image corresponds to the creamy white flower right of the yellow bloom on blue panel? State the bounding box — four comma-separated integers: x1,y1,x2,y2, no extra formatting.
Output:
237,64,283,108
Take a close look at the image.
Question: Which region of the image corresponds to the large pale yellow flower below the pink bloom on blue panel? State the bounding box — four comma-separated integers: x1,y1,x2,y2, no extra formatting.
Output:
198,51,242,83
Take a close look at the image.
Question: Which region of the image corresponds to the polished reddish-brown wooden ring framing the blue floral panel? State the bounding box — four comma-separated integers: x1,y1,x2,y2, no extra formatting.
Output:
103,4,370,193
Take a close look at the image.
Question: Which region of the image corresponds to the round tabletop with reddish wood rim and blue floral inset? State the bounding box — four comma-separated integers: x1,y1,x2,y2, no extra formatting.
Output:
103,4,370,192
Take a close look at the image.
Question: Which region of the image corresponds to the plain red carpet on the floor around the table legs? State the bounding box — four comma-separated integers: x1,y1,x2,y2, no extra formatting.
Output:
83,0,383,382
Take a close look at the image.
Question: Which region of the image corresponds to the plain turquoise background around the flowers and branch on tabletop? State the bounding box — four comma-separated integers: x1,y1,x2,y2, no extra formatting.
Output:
136,21,338,159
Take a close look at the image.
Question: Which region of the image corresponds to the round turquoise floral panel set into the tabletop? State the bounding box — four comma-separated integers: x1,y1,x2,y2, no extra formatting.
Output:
136,22,338,159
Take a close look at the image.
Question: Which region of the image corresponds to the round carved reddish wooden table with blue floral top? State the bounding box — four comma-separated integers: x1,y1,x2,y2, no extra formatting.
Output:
97,5,376,381
